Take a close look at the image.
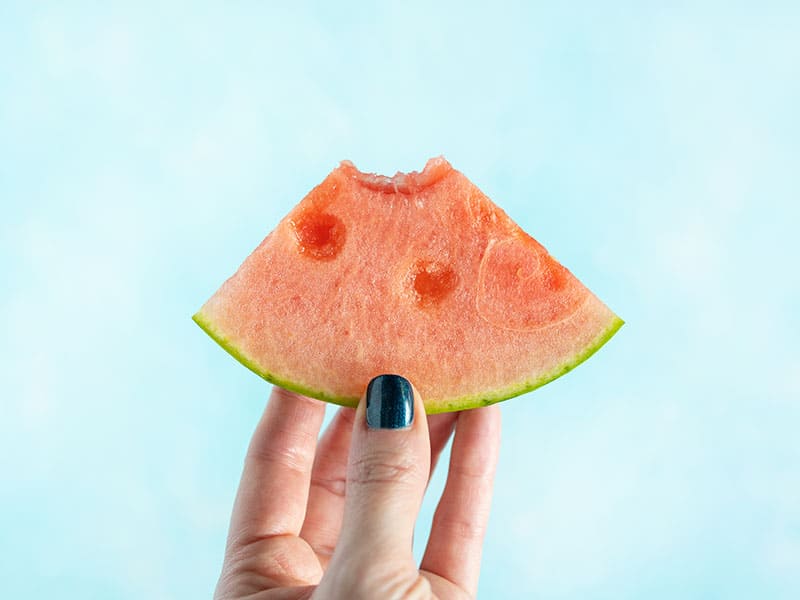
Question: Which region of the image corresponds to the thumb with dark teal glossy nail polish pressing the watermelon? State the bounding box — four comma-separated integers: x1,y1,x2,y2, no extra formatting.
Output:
328,375,430,575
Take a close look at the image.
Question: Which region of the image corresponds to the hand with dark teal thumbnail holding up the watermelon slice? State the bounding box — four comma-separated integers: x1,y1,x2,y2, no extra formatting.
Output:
215,375,500,600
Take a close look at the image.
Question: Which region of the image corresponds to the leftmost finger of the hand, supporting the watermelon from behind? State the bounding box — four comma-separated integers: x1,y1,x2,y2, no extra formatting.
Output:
228,386,325,546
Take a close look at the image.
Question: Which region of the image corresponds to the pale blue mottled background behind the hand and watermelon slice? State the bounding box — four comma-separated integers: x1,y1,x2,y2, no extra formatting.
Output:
0,2,800,600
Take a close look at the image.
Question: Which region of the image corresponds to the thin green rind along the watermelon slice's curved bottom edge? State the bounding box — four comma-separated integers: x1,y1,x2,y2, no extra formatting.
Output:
192,311,625,415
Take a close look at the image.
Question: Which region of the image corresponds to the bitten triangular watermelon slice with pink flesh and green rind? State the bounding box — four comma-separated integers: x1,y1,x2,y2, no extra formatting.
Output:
193,158,623,413
